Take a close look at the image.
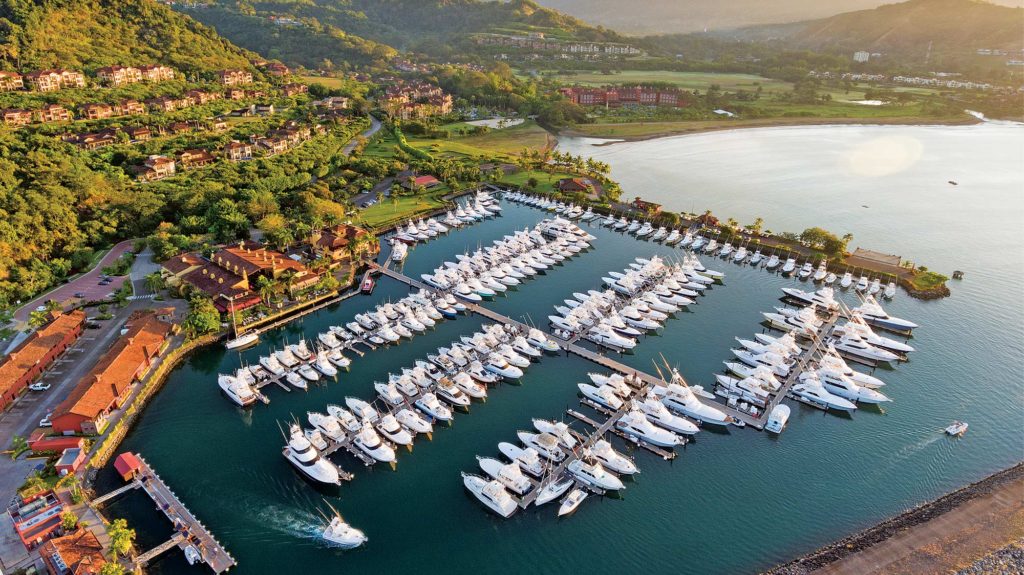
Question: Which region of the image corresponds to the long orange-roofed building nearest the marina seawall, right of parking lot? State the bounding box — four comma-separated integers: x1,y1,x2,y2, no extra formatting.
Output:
50,308,174,435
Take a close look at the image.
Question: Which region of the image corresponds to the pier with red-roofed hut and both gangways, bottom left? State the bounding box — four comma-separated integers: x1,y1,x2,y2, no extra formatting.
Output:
89,453,236,575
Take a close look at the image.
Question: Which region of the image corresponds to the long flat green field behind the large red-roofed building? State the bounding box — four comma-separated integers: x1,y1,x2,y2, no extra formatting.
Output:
520,70,793,92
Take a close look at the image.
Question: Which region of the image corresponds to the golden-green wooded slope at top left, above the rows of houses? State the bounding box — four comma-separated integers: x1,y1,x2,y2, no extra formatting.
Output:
0,0,254,72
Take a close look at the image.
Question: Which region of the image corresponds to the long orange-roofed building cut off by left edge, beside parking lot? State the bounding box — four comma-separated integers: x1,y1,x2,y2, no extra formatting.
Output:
0,310,85,409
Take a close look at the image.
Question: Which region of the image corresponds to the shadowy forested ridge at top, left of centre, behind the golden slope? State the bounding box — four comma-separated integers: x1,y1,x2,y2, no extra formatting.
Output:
187,0,621,65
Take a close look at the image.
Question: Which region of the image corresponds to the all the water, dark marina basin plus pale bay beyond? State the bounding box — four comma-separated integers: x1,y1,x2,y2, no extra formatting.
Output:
99,127,1024,574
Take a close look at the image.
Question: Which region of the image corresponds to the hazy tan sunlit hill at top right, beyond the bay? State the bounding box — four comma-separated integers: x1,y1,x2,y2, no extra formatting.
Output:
787,0,1024,56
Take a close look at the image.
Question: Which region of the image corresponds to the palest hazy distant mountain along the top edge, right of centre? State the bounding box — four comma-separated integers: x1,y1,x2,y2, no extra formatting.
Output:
541,0,1024,35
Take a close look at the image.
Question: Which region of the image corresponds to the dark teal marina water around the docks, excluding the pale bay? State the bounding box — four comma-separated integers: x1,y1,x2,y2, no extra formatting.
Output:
98,162,1024,575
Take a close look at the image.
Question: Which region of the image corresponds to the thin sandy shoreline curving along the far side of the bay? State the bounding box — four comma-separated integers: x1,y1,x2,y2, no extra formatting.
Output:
555,117,984,146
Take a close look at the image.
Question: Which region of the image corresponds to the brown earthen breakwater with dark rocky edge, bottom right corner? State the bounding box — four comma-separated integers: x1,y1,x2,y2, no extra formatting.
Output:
761,462,1024,575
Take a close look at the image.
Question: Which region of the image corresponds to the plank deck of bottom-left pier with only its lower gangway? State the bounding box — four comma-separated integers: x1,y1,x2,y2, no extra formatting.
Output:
136,455,236,574
